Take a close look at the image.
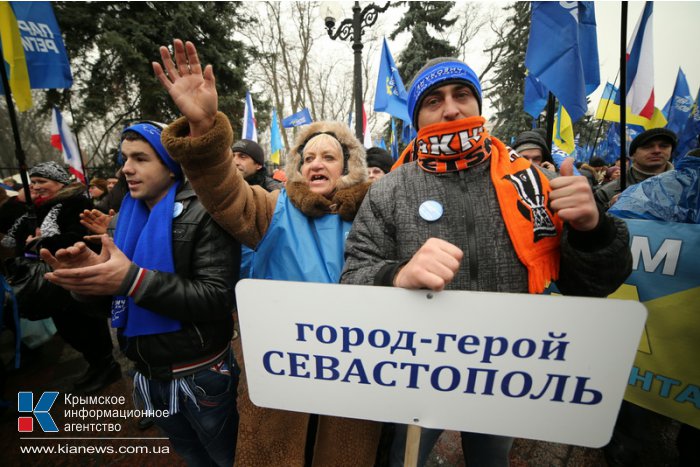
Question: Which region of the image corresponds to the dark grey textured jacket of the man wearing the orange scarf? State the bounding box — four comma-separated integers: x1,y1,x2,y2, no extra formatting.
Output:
341,162,632,297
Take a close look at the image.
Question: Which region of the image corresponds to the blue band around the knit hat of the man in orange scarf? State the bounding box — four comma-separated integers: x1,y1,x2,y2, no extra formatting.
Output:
408,60,481,129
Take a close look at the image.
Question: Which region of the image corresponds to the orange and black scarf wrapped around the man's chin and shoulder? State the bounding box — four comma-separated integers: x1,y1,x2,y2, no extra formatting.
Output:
392,116,563,293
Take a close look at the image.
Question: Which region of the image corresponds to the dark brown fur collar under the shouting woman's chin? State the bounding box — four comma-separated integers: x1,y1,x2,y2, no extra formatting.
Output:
286,182,371,222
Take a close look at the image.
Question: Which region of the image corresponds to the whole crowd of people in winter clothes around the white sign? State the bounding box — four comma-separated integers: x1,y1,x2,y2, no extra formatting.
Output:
0,40,697,466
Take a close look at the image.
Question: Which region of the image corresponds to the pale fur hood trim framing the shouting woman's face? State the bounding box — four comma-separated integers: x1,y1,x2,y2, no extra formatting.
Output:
284,121,367,190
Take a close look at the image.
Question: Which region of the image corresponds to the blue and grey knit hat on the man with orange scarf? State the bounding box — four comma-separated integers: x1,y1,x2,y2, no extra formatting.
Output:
407,57,481,130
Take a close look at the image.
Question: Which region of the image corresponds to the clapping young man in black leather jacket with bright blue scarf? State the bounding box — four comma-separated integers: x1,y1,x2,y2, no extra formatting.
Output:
41,122,240,467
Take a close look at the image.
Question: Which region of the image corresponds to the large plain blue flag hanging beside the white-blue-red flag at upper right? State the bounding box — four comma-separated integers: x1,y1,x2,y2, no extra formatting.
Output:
525,2,600,122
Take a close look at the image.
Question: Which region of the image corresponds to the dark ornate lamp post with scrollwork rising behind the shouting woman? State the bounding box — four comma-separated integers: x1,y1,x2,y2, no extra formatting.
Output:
325,2,391,141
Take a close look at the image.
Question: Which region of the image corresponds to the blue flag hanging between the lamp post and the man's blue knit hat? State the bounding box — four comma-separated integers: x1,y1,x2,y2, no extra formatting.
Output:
374,39,411,125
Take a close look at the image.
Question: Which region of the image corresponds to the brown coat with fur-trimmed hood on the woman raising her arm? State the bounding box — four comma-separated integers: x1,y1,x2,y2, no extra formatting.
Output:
162,113,381,467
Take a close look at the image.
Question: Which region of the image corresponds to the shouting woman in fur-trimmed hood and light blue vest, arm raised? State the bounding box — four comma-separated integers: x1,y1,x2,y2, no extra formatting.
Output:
154,40,380,467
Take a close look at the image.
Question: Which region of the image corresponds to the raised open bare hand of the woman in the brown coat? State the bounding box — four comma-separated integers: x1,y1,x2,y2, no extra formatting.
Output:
153,39,218,136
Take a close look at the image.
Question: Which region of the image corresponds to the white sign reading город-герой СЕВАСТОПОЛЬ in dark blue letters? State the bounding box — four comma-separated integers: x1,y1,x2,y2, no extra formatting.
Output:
236,279,646,447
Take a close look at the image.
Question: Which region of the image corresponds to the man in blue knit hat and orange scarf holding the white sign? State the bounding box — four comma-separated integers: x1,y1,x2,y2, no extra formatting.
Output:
341,58,632,466
